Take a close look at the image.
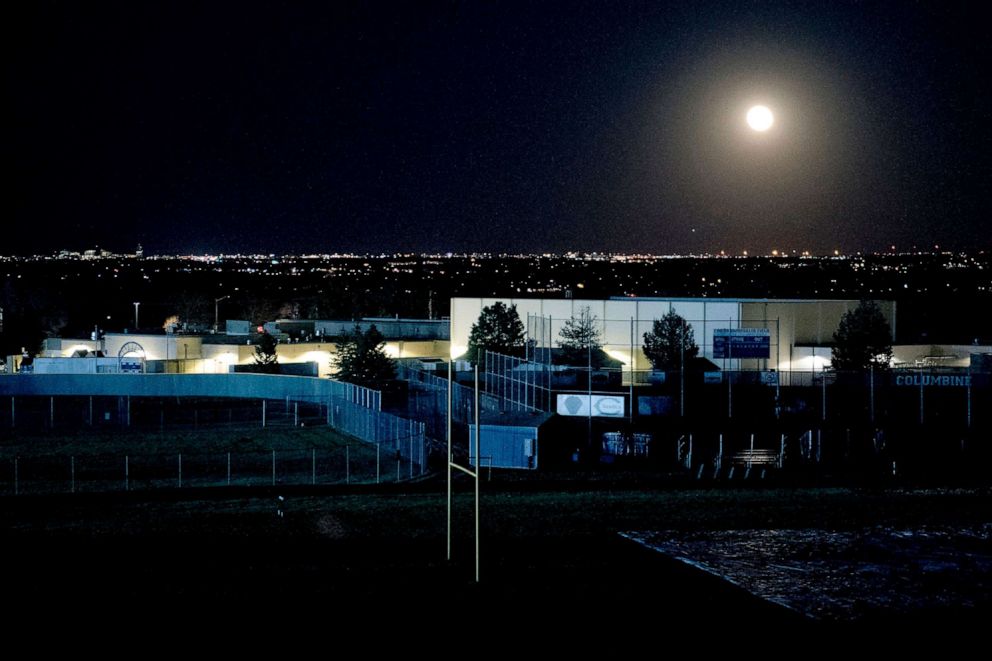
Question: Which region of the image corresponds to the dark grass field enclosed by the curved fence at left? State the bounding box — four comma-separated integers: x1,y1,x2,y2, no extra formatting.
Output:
0,427,396,497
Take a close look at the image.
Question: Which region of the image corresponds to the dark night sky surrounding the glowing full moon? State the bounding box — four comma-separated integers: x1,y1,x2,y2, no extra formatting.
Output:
7,0,992,254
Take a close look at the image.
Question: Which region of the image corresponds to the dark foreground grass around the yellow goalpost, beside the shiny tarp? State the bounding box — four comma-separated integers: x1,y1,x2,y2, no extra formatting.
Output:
0,485,992,631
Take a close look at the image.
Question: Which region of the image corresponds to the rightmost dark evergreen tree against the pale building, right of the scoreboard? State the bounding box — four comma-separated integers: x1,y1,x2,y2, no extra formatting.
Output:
832,301,892,372
